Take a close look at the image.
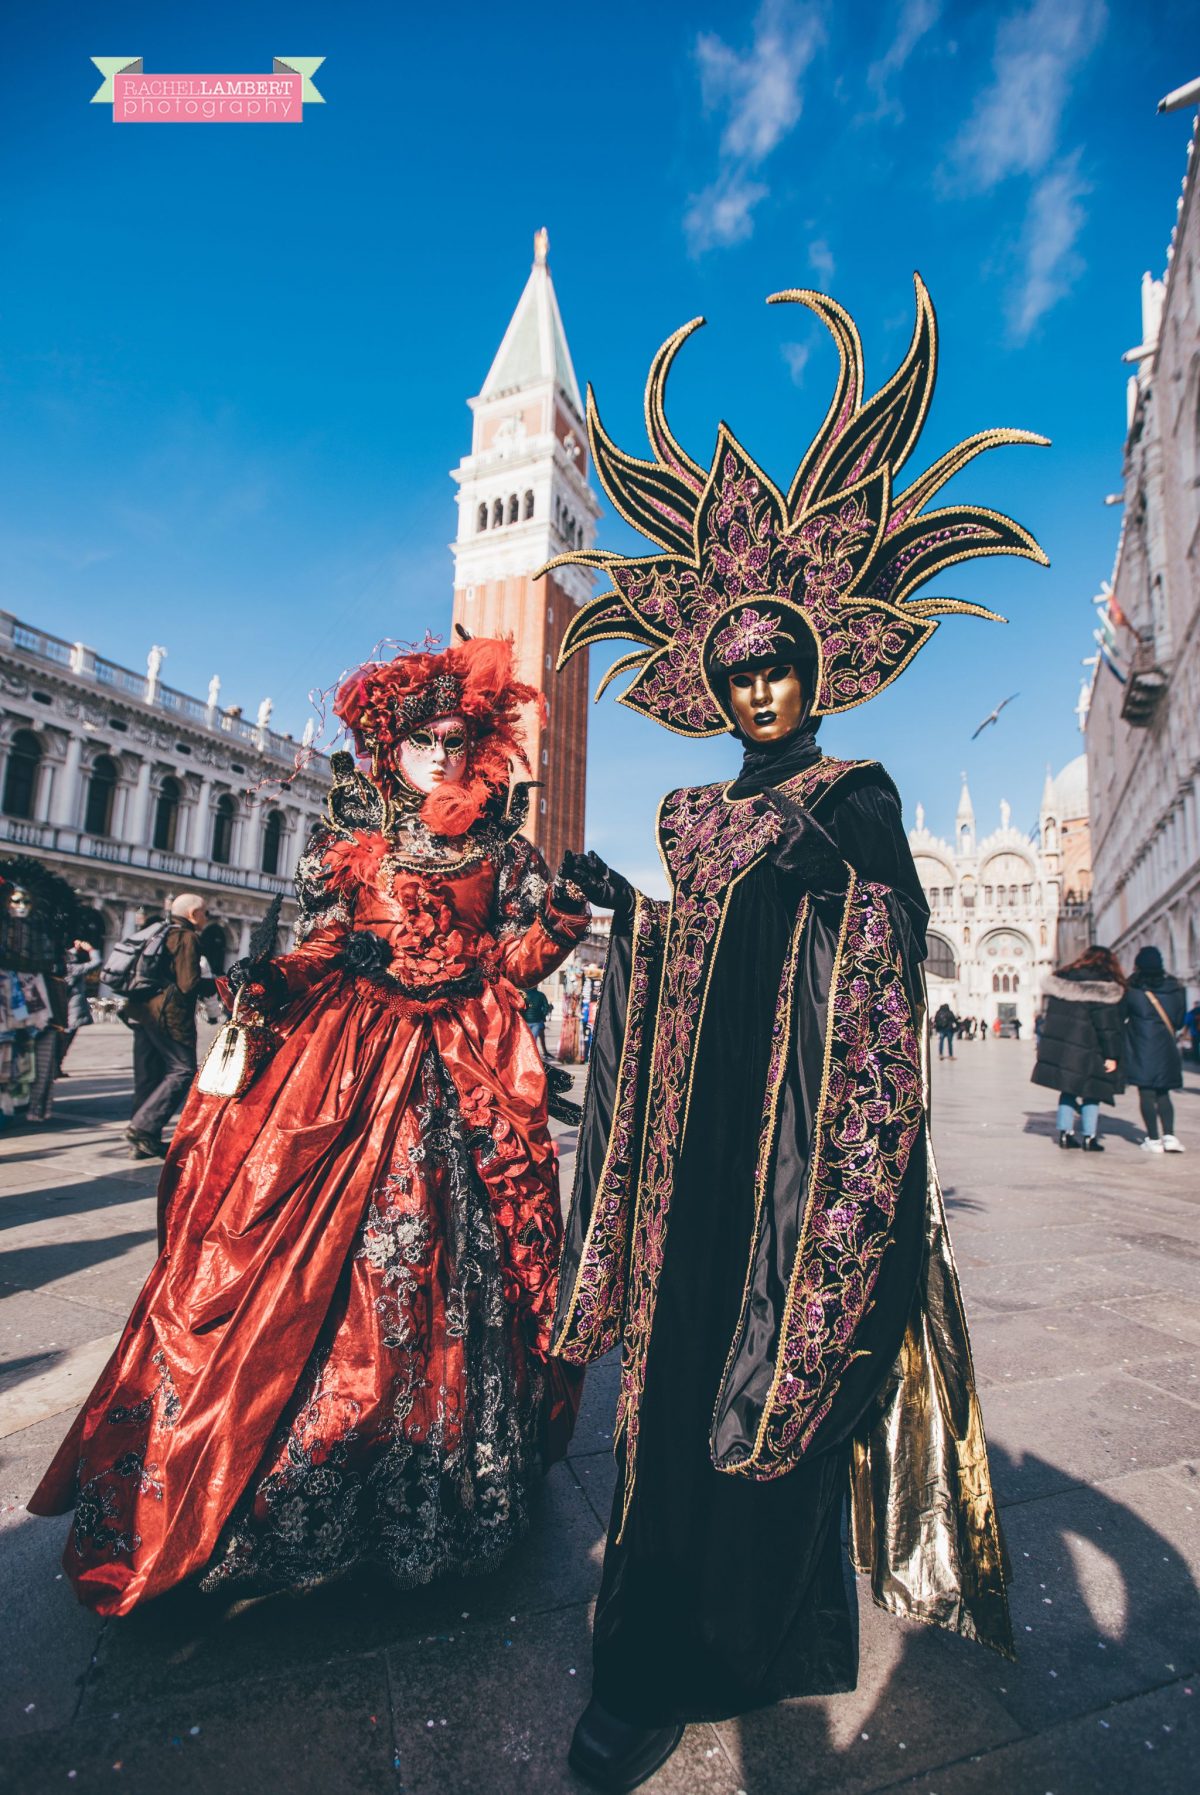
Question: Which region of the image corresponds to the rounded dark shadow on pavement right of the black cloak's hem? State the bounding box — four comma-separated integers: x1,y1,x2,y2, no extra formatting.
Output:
717,1447,1200,1795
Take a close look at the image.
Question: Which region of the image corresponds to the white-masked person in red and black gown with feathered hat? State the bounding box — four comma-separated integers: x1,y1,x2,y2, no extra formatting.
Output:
29,639,588,1614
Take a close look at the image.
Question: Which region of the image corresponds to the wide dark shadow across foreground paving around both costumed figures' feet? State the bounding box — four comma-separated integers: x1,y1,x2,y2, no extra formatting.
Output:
0,1449,1200,1795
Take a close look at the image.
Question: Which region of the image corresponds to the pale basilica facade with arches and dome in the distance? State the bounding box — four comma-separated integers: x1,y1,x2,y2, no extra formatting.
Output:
909,754,1091,1034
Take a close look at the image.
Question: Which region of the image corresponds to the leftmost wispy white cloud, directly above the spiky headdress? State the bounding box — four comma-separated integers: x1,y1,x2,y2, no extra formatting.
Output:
683,0,825,255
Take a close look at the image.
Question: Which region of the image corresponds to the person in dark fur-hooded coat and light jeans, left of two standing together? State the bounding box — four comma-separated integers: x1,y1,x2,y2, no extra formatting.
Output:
1031,948,1125,1152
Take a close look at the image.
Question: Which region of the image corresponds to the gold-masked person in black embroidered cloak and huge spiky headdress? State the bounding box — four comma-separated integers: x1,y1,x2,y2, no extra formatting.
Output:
541,280,1046,1790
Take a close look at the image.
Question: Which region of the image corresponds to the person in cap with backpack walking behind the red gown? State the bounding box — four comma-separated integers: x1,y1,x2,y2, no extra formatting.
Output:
115,892,215,1160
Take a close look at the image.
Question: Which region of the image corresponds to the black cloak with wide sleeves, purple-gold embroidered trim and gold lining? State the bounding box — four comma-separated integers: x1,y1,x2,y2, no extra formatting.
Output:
554,752,1012,1725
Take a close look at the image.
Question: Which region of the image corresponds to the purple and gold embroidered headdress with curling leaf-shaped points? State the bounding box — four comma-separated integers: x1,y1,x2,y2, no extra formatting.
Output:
542,275,1046,736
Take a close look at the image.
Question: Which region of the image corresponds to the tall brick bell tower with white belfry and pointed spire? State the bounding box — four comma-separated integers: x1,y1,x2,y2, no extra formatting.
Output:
452,230,599,872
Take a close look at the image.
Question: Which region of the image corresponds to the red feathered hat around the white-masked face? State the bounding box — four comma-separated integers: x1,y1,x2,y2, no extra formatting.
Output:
334,635,545,835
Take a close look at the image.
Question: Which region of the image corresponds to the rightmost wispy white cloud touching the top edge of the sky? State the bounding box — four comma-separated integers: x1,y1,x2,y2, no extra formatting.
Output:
947,0,1107,192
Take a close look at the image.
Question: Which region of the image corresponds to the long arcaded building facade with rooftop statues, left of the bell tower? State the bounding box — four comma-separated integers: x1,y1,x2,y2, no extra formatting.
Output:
0,610,328,955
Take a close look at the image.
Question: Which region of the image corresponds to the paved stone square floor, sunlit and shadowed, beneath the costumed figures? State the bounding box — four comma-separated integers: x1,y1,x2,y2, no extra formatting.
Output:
0,1025,1200,1795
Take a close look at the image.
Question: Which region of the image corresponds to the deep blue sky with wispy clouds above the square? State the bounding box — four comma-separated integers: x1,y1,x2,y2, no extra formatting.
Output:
0,0,1200,886
